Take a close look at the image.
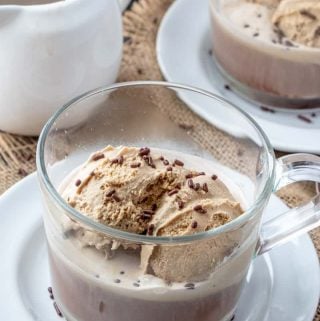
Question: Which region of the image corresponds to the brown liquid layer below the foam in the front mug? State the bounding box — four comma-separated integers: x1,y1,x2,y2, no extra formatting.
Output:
49,245,243,321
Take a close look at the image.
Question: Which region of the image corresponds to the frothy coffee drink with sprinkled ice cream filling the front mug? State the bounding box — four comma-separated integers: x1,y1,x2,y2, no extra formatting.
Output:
47,146,255,321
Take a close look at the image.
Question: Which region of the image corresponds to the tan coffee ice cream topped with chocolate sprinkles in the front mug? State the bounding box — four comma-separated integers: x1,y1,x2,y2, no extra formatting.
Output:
62,146,243,282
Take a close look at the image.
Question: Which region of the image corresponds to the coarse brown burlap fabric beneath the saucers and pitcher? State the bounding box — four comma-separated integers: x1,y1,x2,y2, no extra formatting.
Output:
0,0,320,321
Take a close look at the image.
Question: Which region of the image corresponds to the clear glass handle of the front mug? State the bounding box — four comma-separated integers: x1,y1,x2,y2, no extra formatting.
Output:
256,154,320,255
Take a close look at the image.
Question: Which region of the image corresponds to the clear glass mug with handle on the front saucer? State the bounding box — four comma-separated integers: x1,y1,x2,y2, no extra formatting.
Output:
37,81,320,321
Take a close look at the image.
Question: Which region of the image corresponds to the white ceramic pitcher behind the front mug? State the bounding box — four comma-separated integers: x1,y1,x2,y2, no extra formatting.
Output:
0,0,122,135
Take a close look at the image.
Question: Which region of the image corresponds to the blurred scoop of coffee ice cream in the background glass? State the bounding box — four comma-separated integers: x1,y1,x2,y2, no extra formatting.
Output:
272,0,320,48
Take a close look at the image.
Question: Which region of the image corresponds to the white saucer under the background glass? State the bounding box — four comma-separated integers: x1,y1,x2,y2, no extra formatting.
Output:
157,0,320,153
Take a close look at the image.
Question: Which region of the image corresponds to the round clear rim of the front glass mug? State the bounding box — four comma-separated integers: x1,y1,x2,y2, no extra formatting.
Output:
36,81,275,245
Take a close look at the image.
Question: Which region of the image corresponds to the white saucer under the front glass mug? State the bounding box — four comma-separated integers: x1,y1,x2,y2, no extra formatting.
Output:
0,174,320,321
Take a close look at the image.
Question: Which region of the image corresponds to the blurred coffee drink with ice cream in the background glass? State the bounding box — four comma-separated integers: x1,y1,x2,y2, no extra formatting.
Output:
211,0,320,108
